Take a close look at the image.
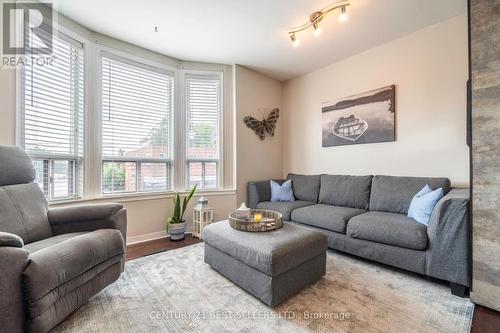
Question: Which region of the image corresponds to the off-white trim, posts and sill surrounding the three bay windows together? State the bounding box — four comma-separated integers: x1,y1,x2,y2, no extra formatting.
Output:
15,22,229,205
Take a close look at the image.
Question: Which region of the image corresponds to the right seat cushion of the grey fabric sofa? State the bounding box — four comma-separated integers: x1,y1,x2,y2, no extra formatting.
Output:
347,211,427,250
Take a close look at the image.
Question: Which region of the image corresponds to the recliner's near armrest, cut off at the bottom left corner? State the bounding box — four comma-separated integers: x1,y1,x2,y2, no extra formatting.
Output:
0,246,29,333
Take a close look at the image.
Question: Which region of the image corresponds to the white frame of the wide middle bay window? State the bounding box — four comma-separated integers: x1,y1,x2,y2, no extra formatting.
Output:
97,49,177,197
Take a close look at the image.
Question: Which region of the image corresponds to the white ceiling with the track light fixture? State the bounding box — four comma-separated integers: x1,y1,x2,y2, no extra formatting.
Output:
57,0,466,81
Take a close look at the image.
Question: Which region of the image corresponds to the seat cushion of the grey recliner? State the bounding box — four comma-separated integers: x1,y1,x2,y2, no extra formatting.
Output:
23,229,124,304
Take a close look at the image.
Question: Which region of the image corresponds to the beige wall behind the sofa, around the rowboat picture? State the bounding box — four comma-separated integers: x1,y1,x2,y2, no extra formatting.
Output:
283,16,469,186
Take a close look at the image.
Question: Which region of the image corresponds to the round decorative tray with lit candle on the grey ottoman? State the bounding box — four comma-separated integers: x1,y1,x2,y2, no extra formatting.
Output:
229,209,283,232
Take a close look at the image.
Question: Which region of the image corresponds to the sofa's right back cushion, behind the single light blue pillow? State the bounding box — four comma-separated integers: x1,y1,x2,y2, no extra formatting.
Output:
370,176,451,215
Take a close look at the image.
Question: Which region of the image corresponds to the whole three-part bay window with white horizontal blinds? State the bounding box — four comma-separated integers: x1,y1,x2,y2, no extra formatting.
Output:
18,29,228,201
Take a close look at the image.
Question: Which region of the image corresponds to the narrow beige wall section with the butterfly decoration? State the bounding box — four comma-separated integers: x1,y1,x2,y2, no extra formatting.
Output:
233,65,284,205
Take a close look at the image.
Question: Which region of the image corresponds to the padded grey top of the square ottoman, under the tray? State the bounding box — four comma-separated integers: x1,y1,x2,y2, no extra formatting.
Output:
203,221,328,276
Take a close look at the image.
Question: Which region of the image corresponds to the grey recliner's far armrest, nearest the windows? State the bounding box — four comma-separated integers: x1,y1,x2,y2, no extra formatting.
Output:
47,204,127,241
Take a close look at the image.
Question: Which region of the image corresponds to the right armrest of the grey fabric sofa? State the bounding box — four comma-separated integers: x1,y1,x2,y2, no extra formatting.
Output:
425,189,471,287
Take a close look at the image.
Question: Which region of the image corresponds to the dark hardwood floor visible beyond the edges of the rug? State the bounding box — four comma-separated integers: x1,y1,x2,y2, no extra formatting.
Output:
127,235,500,333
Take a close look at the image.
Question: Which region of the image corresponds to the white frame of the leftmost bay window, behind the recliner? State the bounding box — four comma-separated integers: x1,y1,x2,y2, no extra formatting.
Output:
16,26,88,203
